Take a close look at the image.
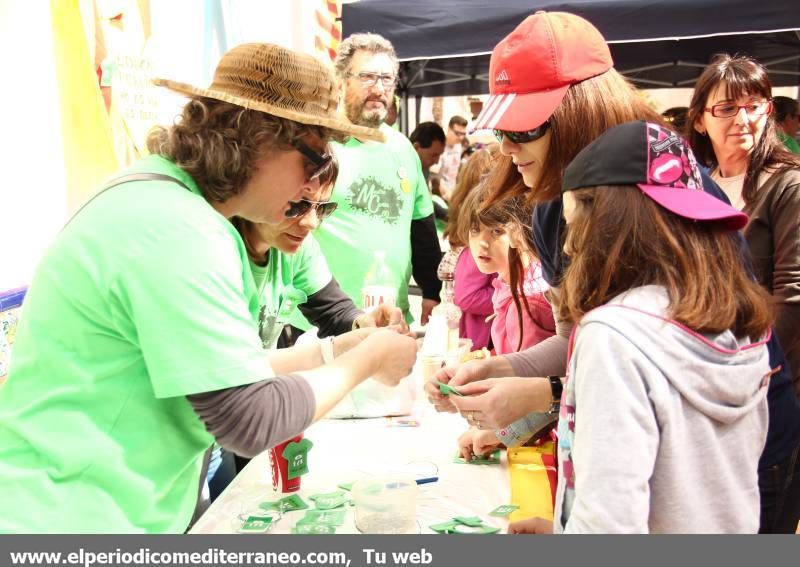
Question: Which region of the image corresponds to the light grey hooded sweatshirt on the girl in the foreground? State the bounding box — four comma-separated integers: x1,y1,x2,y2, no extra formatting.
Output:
554,286,770,533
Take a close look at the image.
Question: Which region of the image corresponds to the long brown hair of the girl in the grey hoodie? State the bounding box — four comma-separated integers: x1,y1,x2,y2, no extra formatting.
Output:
558,186,774,340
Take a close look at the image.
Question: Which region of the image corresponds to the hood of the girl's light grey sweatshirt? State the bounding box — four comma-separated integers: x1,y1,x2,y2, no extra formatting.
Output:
580,285,770,423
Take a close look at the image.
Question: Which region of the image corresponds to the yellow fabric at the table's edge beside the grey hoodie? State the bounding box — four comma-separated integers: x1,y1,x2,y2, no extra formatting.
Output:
508,441,554,522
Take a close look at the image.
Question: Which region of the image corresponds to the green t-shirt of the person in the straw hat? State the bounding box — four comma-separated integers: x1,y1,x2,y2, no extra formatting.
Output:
0,156,273,533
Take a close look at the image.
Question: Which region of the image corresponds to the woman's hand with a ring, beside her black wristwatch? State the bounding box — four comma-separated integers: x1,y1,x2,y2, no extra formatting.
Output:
449,377,552,429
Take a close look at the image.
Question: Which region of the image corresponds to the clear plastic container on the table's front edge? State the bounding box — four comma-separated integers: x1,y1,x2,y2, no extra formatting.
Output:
353,477,417,534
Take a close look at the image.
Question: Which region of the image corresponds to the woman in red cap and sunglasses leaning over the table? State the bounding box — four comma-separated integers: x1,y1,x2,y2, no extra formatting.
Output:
426,12,794,536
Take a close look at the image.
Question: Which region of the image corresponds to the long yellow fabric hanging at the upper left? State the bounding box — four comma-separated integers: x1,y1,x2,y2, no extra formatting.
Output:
50,0,117,213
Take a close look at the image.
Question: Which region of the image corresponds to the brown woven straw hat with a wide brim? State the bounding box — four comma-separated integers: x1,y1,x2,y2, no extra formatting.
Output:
153,43,384,141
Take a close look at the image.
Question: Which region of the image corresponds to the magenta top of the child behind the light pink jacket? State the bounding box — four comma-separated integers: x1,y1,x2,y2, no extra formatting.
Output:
454,247,497,350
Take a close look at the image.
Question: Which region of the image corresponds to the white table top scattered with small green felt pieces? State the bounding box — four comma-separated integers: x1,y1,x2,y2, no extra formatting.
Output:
190,406,510,533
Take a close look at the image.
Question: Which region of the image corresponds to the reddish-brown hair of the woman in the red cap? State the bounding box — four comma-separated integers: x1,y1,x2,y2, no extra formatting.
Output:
488,69,663,205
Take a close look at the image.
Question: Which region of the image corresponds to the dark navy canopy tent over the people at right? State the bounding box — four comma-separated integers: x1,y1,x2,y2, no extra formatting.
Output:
342,0,800,96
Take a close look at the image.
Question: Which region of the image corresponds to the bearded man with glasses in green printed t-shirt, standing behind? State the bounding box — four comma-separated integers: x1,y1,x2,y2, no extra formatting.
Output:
293,33,441,328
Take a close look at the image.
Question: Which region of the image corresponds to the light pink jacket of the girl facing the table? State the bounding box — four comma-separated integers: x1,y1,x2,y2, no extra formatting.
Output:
492,262,556,354
